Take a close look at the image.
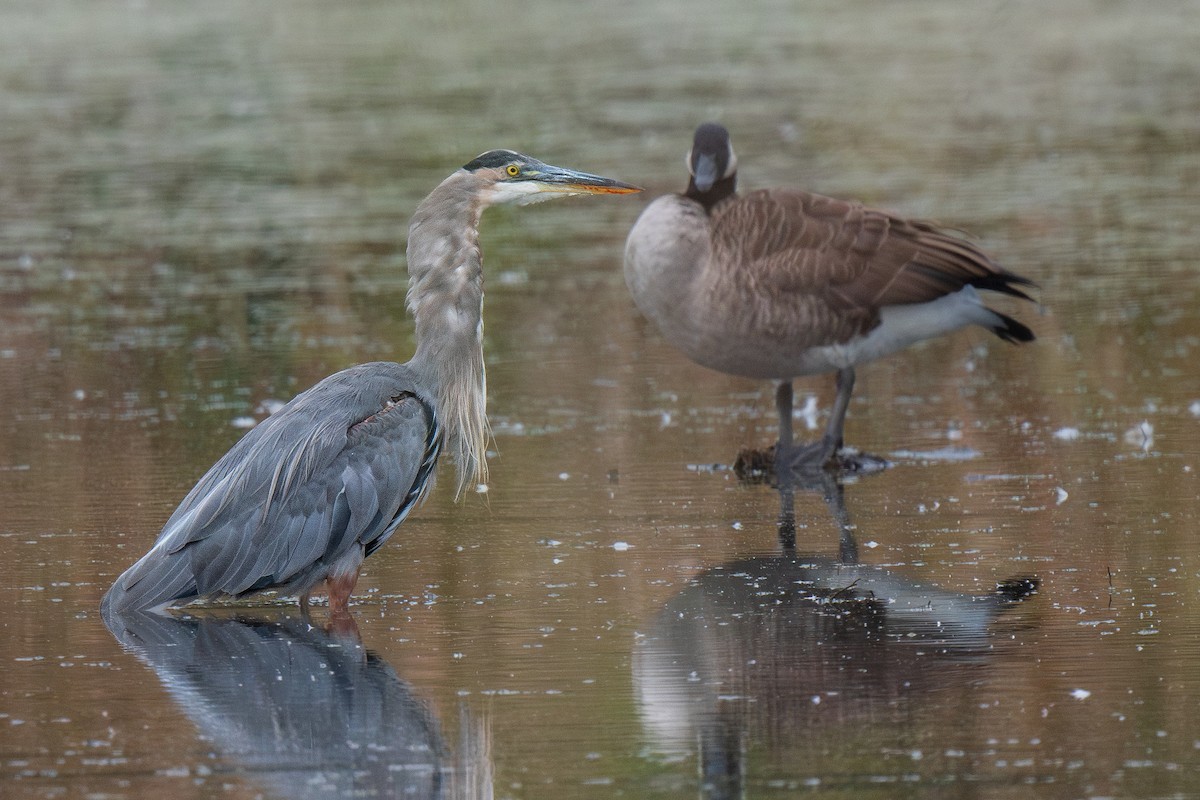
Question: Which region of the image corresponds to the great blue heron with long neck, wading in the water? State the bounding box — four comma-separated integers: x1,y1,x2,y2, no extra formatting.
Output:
101,150,641,618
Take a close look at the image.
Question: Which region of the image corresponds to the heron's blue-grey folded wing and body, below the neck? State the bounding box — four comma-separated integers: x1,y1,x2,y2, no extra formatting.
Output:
104,363,440,608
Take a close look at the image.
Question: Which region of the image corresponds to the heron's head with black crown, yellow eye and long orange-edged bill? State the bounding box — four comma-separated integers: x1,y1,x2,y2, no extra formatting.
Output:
463,150,642,205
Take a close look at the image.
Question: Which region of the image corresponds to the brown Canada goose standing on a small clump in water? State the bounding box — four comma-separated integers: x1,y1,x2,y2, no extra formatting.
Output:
625,122,1033,470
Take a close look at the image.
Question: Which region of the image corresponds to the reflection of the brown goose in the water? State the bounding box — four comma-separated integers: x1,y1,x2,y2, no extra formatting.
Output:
632,476,1037,798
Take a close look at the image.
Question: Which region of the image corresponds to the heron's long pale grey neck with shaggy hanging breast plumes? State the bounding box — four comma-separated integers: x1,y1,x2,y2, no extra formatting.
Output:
408,170,488,494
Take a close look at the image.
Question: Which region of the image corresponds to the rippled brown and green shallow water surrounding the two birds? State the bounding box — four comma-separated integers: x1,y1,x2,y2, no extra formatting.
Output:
0,0,1200,799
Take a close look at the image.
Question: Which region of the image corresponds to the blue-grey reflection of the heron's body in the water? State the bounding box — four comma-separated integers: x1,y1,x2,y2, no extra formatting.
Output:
106,613,484,799
